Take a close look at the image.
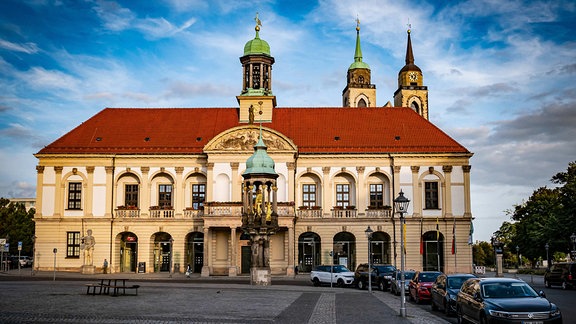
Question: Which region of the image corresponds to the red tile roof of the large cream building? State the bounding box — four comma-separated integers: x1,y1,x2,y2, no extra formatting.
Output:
38,108,469,154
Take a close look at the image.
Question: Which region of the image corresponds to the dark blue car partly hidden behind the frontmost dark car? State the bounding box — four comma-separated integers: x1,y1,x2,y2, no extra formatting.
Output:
430,274,476,315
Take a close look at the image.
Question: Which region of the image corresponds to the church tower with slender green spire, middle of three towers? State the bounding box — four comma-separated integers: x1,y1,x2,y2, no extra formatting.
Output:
342,19,376,108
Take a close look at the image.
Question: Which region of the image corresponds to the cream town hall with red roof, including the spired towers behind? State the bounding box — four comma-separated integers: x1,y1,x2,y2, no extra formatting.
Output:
34,17,473,276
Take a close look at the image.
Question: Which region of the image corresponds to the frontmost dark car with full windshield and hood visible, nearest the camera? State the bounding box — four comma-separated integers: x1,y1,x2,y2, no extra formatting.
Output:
456,278,562,323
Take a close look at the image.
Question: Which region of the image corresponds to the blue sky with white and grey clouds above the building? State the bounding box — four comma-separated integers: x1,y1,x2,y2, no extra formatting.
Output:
0,0,576,240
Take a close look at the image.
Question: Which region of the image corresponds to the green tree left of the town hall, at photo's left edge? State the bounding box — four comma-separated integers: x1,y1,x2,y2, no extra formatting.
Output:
0,198,36,255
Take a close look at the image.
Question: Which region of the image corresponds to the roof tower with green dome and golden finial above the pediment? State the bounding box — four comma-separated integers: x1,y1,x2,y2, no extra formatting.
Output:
236,13,276,124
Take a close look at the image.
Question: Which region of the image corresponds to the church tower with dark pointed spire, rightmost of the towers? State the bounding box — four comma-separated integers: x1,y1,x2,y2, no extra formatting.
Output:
394,29,429,119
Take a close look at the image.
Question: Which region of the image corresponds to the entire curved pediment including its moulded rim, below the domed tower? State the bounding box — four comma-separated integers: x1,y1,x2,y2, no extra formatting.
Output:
204,126,297,152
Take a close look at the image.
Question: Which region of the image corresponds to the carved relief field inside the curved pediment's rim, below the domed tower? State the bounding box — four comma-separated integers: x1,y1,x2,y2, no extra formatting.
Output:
209,128,294,151
